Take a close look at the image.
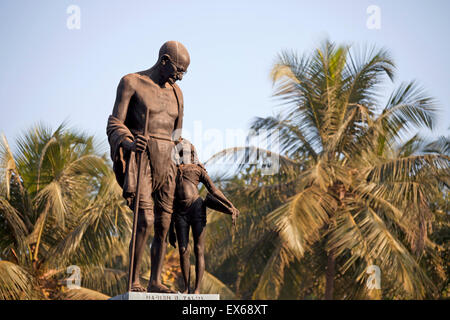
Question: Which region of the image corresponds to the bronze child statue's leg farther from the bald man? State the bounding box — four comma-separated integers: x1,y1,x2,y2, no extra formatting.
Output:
192,200,206,294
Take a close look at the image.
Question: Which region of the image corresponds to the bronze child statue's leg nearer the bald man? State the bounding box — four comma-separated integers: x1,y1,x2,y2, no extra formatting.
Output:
175,217,191,293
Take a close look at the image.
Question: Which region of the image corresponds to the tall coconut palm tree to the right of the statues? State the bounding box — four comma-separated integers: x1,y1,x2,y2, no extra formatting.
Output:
209,41,450,299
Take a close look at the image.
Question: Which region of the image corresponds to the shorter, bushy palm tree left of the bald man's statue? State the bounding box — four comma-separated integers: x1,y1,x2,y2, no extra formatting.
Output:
0,124,131,299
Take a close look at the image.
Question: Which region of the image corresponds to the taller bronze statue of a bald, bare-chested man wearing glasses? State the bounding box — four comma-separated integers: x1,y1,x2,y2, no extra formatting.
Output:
107,41,190,293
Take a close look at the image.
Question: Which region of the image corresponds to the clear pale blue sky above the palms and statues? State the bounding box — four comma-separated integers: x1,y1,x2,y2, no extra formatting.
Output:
0,0,450,160
